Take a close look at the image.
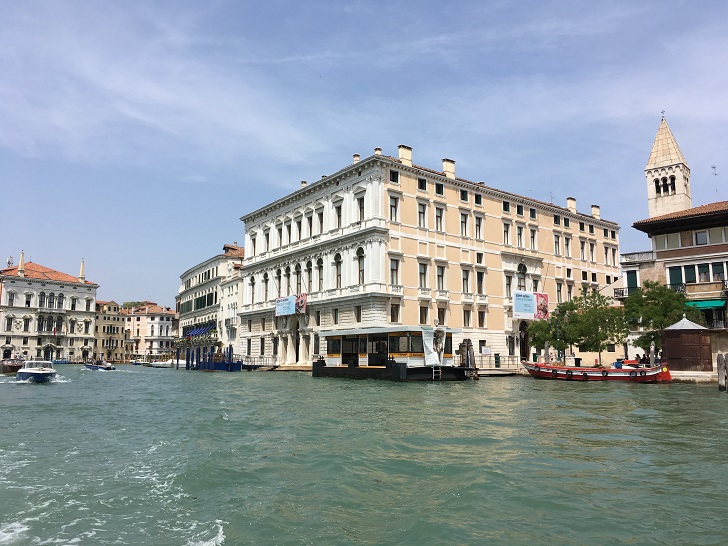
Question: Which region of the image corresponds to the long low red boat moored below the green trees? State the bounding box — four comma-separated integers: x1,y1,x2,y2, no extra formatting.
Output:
523,362,672,383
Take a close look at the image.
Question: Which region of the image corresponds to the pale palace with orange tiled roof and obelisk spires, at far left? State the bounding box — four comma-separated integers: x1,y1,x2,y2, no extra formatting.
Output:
0,251,99,362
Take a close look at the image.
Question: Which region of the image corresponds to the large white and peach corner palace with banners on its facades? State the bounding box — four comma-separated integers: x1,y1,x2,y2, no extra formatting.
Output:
239,145,619,365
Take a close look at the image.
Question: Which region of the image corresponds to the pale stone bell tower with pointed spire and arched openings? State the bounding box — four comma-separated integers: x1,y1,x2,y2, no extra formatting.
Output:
645,115,693,218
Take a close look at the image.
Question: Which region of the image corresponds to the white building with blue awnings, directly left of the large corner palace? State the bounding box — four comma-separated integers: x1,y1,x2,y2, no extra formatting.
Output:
175,241,245,358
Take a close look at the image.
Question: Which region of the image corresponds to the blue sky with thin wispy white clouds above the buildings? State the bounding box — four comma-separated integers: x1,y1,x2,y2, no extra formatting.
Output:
0,0,728,307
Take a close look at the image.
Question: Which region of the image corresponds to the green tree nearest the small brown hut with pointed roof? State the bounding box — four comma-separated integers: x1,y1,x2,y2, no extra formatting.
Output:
624,281,705,352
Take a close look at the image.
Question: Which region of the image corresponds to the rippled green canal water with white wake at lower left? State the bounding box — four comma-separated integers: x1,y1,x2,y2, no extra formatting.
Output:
0,365,728,546
